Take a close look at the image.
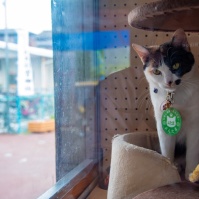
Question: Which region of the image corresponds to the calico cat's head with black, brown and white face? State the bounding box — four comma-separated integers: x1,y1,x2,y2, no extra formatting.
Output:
133,29,194,91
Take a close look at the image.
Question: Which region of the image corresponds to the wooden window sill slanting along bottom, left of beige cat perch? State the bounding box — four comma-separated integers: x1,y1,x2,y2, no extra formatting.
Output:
39,160,98,199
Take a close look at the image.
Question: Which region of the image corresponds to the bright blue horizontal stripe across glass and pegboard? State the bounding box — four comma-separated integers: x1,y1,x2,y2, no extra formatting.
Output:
53,30,130,51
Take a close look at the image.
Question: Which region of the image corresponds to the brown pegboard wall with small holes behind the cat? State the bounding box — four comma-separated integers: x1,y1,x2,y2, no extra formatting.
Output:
99,0,199,183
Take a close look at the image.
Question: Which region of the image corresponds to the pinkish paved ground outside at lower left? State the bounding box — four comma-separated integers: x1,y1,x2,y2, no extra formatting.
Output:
0,133,56,199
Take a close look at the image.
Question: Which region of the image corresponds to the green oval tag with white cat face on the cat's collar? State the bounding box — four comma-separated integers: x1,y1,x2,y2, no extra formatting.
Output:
162,108,182,135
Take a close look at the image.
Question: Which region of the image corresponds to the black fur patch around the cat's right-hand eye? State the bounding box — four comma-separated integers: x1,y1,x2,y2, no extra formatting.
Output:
160,43,195,77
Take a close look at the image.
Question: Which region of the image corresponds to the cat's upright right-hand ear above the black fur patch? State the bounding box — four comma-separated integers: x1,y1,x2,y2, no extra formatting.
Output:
171,29,190,52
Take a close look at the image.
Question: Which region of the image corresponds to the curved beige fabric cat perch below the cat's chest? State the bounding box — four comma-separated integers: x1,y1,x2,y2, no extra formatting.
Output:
108,132,181,199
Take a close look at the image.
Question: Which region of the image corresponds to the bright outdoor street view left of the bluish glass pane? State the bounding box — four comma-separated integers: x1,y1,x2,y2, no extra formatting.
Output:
0,0,56,199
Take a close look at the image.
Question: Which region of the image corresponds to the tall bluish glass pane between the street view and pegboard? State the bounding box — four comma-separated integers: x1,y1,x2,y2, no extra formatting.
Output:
52,0,100,179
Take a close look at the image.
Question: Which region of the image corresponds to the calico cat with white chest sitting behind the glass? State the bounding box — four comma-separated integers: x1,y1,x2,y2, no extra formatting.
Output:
133,29,199,179
